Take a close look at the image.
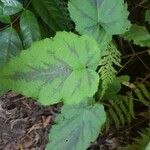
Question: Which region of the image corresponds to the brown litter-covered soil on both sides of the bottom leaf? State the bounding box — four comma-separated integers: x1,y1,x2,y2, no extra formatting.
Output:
0,92,148,150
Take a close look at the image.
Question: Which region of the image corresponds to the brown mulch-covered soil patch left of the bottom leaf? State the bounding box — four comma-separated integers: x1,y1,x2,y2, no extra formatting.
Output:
0,92,58,150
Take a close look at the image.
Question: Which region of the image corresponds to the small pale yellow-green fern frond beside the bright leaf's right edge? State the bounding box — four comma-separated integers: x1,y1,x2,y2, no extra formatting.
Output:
99,42,121,98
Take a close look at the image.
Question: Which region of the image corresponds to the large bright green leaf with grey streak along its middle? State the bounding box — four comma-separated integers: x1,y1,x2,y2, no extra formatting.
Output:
0,32,100,105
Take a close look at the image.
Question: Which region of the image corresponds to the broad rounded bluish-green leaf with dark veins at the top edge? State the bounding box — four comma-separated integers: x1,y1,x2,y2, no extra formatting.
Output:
69,0,130,41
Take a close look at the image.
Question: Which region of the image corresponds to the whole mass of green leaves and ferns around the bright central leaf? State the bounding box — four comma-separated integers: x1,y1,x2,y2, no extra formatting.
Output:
0,0,150,150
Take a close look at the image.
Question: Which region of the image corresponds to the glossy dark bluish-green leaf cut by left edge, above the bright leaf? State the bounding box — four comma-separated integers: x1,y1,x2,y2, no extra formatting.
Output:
0,27,22,67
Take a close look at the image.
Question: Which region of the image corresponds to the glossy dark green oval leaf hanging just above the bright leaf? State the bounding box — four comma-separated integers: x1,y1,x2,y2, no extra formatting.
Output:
20,10,41,48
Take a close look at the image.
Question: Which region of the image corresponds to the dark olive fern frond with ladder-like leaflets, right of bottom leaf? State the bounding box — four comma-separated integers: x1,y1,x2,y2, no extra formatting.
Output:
108,84,150,128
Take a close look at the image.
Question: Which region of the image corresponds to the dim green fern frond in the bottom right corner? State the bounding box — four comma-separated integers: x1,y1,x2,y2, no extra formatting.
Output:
124,127,150,150
